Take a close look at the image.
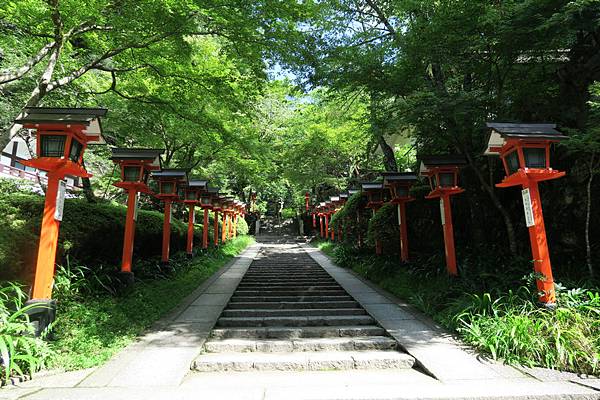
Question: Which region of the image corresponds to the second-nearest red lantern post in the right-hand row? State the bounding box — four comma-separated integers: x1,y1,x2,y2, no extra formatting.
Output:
421,155,466,276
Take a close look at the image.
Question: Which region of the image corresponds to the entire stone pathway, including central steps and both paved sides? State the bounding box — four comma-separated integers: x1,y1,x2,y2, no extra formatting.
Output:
0,238,600,400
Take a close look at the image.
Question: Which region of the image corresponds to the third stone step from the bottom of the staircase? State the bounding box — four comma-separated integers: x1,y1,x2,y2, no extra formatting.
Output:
210,325,386,339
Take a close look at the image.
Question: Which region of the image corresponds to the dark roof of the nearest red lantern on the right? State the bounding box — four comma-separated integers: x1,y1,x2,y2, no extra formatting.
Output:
484,122,568,155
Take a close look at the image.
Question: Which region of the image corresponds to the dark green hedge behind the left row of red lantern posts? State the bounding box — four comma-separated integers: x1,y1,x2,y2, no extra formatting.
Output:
0,193,202,280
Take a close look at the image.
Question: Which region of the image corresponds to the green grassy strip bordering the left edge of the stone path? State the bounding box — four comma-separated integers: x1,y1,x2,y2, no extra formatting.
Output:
49,236,253,370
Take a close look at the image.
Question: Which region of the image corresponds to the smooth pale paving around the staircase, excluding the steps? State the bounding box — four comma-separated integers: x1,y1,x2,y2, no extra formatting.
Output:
0,241,600,400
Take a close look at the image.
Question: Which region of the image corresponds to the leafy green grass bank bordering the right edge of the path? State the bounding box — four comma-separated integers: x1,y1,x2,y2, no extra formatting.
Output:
318,242,600,374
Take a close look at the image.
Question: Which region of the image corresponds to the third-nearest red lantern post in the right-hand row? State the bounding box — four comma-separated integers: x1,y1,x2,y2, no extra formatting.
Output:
382,172,417,262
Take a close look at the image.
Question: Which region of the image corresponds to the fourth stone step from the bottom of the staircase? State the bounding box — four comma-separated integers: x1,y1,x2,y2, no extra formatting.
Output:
217,315,375,327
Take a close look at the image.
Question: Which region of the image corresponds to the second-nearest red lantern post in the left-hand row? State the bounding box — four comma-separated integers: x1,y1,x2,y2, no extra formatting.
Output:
111,148,164,283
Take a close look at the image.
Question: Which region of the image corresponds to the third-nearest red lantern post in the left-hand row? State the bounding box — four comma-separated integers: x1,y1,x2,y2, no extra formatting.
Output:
152,168,187,265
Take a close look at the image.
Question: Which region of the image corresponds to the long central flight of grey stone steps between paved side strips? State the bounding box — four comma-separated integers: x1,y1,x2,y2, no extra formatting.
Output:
192,245,415,372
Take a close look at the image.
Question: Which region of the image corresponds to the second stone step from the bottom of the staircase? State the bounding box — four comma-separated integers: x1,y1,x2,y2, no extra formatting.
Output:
203,336,398,353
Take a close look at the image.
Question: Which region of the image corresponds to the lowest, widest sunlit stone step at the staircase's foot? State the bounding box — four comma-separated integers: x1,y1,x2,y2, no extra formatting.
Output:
192,351,415,372
